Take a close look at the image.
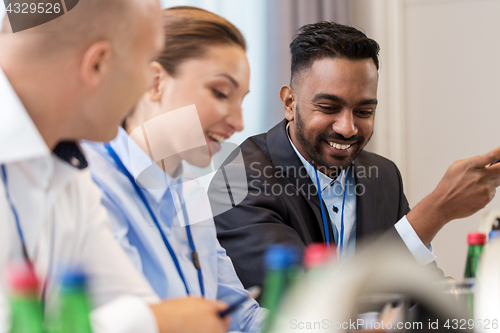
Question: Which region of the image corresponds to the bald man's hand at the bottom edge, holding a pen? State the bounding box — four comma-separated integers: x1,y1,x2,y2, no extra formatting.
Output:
151,297,229,333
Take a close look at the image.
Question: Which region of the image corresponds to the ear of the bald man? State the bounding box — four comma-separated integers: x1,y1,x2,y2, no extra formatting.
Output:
80,41,113,88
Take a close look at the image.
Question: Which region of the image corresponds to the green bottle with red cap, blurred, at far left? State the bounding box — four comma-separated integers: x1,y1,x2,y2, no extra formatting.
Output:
8,262,43,333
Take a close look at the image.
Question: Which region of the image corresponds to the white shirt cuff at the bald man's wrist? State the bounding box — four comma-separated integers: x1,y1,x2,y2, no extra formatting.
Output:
91,296,158,333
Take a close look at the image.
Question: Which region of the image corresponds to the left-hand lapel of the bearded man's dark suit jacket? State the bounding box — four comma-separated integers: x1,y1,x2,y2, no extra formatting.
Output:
266,119,334,240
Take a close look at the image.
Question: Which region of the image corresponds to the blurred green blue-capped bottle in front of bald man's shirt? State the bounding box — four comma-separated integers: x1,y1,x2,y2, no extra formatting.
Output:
61,269,92,333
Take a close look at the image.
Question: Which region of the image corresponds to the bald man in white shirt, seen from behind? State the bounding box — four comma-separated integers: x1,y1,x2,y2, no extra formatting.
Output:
0,0,228,333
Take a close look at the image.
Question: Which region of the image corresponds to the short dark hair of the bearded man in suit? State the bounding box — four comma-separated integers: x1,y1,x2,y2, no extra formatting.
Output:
290,21,380,85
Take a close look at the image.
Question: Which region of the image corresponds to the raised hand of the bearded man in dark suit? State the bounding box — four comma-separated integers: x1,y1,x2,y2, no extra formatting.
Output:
407,147,500,246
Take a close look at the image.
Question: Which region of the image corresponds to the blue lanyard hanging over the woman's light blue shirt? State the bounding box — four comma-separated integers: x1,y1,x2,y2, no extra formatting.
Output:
105,143,205,296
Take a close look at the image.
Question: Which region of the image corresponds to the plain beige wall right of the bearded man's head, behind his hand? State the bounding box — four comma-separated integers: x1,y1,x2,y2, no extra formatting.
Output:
349,0,500,278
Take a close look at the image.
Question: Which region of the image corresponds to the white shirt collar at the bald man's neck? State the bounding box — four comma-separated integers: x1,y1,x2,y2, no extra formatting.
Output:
0,67,50,164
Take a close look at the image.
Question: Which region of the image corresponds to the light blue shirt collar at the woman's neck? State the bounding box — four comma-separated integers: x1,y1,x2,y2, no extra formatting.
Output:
109,127,181,202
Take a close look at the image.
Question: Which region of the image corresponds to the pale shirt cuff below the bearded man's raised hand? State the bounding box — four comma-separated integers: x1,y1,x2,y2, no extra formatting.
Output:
394,215,436,265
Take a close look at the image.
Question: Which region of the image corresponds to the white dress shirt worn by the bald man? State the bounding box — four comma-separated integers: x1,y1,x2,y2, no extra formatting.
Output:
0,68,159,333
